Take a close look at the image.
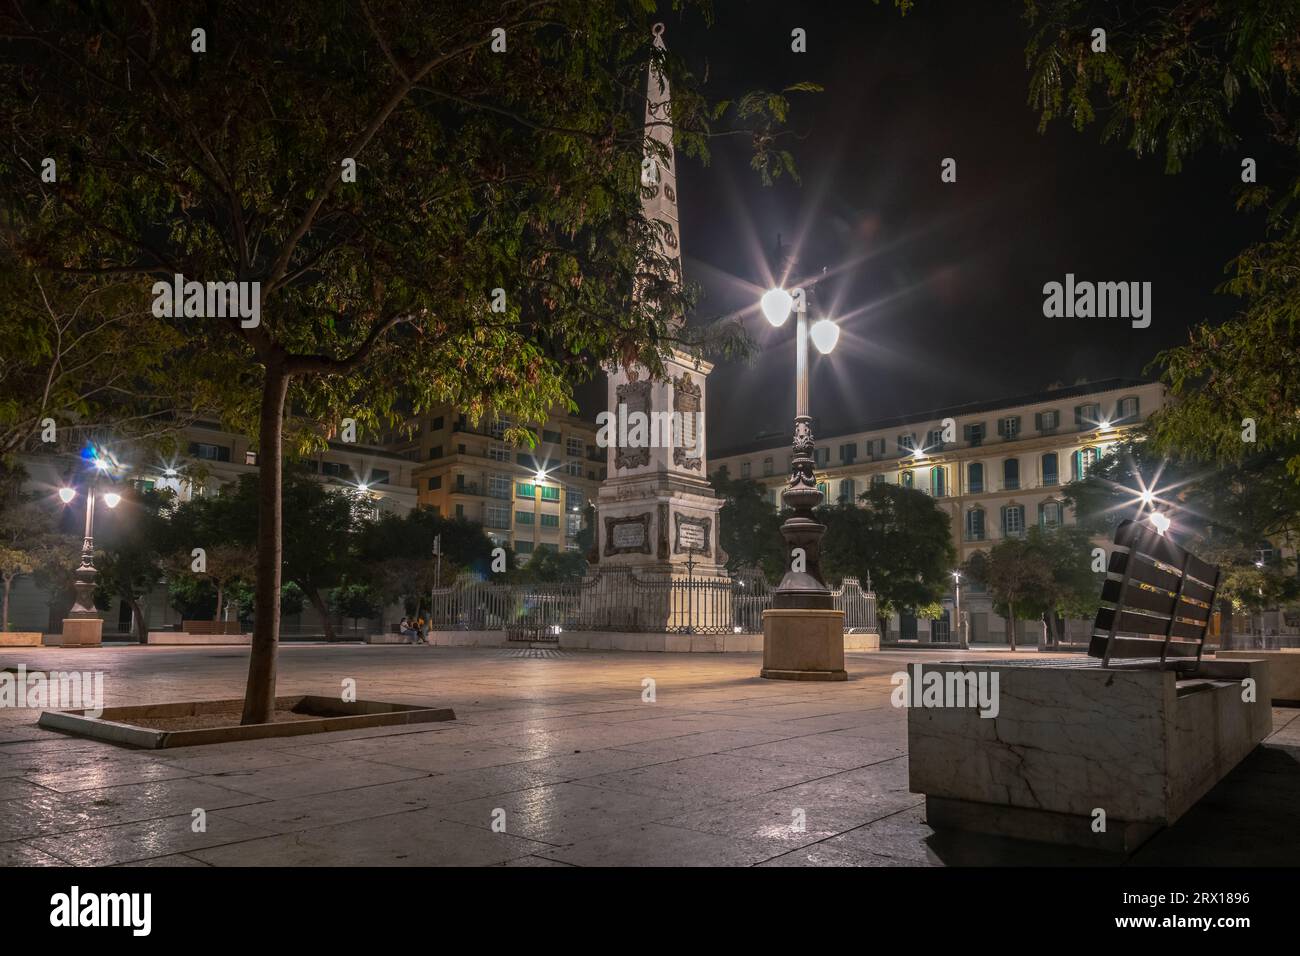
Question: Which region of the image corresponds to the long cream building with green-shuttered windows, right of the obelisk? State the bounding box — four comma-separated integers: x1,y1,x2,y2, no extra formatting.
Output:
714,380,1166,643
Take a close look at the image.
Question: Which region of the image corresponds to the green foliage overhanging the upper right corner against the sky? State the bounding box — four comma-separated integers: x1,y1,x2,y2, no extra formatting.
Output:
1026,0,1300,483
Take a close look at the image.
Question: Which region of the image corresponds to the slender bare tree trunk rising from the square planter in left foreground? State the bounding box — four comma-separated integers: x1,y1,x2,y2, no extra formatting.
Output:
241,364,289,723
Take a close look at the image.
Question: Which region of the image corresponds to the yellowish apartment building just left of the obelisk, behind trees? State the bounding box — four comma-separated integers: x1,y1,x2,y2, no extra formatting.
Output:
387,406,607,559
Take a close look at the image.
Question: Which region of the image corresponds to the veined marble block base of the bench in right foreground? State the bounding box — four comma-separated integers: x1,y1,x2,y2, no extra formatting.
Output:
906,661,1273,852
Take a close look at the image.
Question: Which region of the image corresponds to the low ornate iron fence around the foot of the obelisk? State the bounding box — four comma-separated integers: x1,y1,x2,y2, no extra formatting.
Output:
429,570,876,639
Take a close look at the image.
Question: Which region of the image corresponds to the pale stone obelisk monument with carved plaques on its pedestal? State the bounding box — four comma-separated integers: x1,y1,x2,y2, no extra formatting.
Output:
595,23,727,590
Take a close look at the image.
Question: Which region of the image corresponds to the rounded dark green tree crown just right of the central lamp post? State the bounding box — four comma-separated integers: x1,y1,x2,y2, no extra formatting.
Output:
816,484,957,617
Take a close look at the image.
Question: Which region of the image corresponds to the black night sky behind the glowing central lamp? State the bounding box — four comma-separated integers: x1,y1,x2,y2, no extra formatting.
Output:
582,0,1269,455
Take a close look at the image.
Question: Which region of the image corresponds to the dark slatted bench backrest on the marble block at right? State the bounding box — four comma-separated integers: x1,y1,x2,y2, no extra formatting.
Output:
1088,520,1221,665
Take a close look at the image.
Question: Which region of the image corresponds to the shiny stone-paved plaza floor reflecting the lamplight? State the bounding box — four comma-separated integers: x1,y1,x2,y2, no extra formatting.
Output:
0,645,1300,866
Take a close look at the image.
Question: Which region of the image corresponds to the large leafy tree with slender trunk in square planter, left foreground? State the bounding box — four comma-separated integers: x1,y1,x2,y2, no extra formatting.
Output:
0,0,792,722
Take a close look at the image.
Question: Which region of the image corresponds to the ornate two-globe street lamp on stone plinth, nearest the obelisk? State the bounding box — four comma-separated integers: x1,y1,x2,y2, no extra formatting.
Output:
761,278,848,680
